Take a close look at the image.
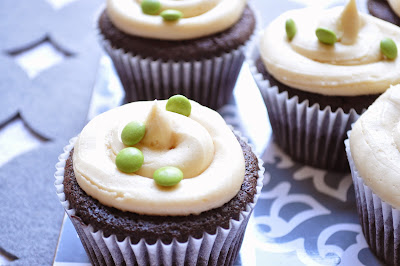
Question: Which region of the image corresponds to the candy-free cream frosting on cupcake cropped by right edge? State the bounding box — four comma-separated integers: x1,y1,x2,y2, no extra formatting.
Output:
350,85,400,208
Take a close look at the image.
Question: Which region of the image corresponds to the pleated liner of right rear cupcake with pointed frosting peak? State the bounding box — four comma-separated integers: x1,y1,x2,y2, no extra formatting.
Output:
247,36,360,171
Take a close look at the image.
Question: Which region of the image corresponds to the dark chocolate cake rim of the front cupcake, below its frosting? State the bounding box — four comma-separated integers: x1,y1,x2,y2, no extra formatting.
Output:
63,137,259,244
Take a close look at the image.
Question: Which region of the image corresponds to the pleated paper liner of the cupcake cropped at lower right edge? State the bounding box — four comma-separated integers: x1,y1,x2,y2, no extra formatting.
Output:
345,137,400,265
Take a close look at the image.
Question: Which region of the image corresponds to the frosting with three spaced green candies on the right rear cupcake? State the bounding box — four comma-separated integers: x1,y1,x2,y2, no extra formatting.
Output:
260,0,400,96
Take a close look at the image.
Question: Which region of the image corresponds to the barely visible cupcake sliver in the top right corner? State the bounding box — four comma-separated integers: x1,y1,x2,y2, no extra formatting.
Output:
367,0,400,26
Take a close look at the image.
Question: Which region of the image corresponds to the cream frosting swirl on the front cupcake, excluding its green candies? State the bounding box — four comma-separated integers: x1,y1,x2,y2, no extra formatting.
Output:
73,101,245,215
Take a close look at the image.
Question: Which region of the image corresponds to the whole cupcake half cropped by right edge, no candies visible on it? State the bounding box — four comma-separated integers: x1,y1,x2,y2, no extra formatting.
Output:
345,85,400,265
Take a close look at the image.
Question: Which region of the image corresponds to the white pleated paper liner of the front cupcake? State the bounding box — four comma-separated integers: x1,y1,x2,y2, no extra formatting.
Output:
54,132,264,265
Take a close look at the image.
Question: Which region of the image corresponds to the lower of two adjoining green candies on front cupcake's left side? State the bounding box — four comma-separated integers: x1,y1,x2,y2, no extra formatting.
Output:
115,147,144,174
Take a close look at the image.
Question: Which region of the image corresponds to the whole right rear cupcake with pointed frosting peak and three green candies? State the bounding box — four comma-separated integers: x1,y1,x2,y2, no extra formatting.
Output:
249,0,400,171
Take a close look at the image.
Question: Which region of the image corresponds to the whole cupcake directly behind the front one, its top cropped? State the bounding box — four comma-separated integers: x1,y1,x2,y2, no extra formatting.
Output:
98,0,256,109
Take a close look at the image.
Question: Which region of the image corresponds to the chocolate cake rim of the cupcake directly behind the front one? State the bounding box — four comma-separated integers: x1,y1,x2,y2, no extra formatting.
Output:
99,7,255,61
